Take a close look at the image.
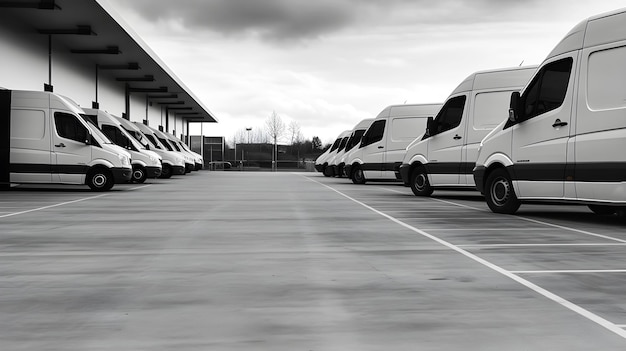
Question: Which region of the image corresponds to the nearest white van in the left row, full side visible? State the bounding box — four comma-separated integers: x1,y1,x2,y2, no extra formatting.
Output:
0,90,132,191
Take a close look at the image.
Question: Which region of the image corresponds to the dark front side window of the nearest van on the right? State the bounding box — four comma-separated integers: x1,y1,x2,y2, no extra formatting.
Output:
520,57,573,121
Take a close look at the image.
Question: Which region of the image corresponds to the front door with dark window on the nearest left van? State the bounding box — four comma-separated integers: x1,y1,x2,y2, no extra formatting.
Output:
51,111,92,184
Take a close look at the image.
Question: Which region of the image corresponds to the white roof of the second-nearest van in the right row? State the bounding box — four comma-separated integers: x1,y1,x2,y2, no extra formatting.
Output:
450,66,537,95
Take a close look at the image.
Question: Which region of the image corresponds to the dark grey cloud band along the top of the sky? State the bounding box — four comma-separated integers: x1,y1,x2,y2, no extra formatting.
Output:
109,0,536,42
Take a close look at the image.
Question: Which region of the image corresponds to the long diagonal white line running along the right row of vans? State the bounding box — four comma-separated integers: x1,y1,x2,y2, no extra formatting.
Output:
303,176,626,339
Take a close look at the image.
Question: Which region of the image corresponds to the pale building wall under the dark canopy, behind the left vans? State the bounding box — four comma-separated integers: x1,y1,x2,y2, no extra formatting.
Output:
0,14,187,142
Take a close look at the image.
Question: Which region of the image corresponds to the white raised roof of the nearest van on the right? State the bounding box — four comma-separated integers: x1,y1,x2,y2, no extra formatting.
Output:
546,8,626,60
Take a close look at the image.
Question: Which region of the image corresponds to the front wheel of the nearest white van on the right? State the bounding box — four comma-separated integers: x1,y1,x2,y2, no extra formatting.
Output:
485,168,522,214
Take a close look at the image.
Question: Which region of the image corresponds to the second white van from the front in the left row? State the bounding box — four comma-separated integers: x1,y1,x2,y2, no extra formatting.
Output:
83,108,161,183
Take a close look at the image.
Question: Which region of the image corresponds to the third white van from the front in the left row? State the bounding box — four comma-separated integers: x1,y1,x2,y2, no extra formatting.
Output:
132,120,185,178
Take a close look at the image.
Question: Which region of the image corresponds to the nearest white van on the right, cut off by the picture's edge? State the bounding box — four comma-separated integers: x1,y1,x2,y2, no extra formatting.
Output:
474,9,626,214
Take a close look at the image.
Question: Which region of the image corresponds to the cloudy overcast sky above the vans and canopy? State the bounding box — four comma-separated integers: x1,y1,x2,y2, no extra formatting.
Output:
109,0,626,142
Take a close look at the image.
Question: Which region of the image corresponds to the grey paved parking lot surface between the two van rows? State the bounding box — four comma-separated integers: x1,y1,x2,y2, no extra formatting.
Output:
0,171,626,351
